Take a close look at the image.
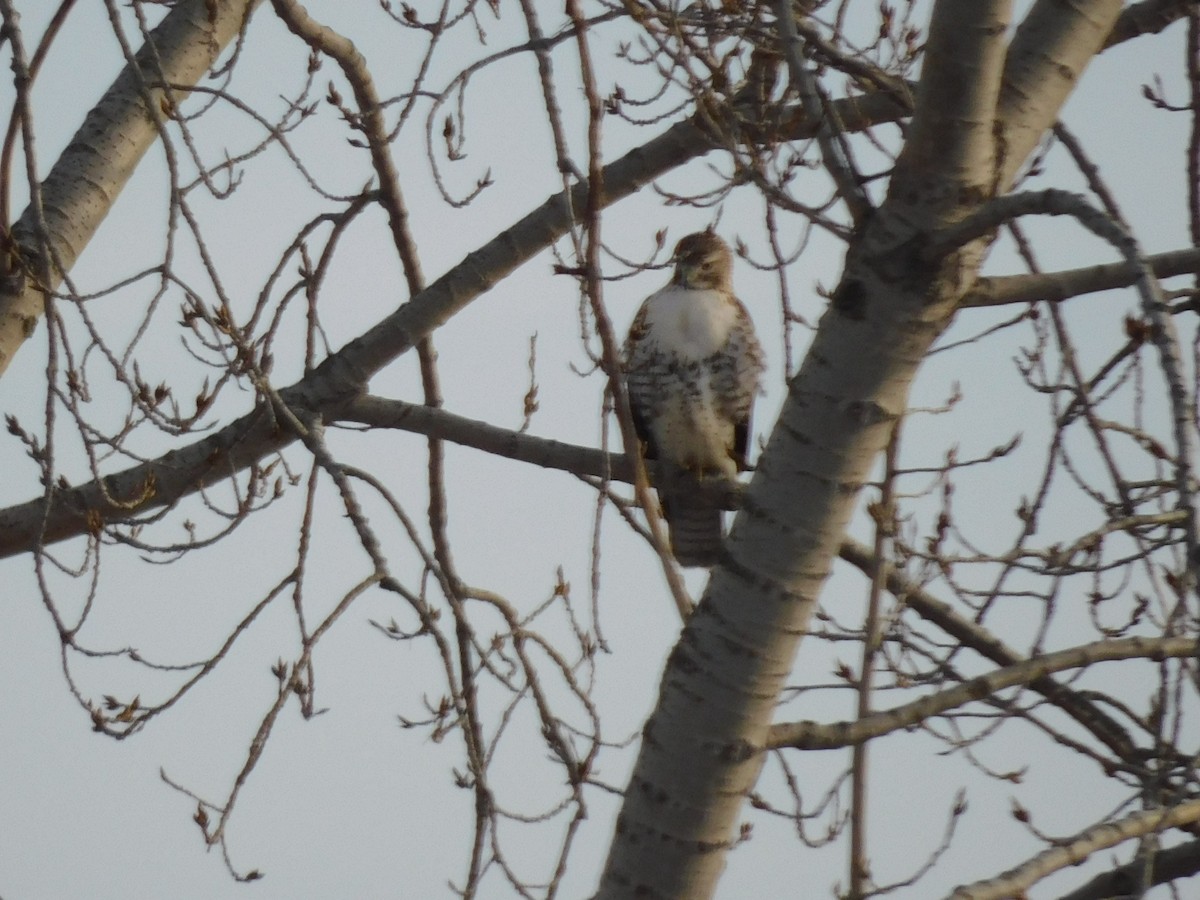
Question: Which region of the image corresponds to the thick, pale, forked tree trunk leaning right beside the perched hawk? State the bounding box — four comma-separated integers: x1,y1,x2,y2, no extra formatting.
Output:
598,0,1121,900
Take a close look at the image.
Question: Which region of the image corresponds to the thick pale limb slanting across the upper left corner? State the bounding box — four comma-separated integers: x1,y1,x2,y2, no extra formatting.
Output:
0,0,260,376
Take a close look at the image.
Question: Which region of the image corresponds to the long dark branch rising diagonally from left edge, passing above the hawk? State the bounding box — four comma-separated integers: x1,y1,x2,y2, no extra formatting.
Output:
0,92,904,558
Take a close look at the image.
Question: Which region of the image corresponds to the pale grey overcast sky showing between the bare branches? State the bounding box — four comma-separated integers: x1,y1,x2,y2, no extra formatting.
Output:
0,0,1188,900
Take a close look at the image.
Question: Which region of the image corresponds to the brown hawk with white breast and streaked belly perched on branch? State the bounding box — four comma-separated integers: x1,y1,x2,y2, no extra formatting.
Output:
623,230,763,566
